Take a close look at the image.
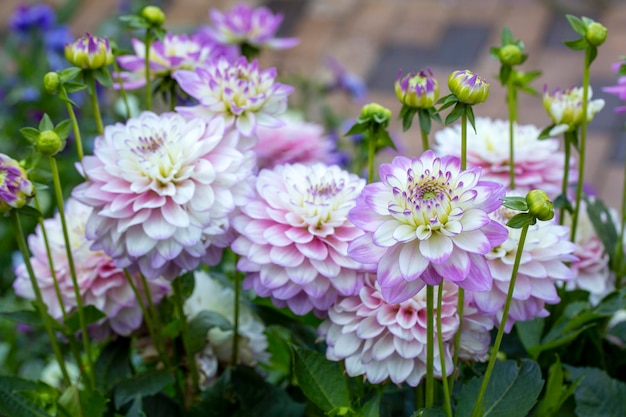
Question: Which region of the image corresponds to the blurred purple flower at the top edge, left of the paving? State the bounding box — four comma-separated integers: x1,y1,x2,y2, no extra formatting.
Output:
204,4,298,49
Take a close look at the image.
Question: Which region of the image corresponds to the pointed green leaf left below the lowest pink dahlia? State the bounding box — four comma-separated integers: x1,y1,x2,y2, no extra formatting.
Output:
292,345,350,411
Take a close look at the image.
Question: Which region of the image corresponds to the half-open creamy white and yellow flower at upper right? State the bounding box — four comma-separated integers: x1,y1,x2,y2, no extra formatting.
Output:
543,86,604,136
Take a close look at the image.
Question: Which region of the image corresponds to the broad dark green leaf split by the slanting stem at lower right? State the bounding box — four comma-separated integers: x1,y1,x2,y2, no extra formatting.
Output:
456,359,544,417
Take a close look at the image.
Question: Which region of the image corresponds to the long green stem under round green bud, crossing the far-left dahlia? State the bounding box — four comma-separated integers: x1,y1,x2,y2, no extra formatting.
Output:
50,156,96,389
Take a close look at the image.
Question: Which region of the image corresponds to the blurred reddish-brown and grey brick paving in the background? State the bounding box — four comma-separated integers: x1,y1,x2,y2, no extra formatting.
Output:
0,0,626,208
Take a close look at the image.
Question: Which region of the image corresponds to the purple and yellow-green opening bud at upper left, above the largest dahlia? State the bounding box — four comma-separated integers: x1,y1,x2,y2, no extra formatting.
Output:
65,33,114,70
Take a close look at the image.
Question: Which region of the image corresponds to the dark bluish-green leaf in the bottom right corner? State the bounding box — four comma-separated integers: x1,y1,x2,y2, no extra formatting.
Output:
565,365,626,417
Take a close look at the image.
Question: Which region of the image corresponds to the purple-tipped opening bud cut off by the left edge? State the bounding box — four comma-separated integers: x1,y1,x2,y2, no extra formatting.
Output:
0,153,35,213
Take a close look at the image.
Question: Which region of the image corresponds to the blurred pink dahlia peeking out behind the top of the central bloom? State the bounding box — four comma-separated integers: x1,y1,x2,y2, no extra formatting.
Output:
253,117,338,169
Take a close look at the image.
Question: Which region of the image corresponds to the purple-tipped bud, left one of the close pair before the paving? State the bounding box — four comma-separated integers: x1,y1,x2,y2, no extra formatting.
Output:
394,69,439,109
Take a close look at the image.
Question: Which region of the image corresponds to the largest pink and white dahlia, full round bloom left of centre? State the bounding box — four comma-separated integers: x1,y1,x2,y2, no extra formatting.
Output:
73,112,255,280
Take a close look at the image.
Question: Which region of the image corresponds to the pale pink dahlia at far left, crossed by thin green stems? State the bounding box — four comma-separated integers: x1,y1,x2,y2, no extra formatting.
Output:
13,199,170,339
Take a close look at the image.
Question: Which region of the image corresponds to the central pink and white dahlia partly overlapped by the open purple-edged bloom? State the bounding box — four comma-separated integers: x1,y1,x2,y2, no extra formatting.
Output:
232,163,365,316
